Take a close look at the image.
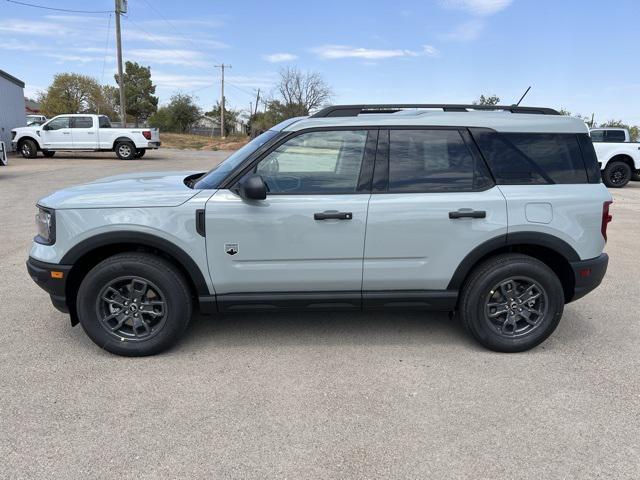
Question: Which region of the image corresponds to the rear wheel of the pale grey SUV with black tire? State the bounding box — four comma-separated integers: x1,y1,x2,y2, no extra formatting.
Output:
458,253,564,353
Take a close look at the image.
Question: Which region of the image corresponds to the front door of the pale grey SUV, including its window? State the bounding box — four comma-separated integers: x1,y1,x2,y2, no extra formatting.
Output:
206,130,377,305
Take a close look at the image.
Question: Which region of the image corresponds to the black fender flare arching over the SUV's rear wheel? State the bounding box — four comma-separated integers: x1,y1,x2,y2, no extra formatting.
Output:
447,232,580,290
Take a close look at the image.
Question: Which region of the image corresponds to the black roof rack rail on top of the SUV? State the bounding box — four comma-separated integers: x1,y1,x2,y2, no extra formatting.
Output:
311,103,560,118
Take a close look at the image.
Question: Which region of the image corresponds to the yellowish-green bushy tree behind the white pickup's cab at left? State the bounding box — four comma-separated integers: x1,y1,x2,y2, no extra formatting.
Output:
38,73,104,116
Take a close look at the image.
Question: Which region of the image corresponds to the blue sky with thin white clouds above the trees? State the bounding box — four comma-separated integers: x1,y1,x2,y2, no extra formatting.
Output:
0,0,640,124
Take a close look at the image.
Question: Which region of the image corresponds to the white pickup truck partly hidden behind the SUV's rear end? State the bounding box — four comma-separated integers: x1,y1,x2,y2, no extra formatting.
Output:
590,128,640,188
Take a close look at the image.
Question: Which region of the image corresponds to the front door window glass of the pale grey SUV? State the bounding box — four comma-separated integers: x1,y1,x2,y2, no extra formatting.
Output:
254,130,367,194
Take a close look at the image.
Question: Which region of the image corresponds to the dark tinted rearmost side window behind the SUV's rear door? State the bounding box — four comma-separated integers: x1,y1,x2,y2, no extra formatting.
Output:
471,129,588,185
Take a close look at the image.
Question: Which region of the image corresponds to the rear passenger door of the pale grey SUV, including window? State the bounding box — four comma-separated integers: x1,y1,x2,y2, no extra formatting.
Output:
363,128,507,292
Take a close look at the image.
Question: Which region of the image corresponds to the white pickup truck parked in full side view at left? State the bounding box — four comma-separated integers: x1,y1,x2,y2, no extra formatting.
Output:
11,114,160,160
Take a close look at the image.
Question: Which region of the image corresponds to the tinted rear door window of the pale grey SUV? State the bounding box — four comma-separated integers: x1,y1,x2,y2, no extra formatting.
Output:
389,130,488,192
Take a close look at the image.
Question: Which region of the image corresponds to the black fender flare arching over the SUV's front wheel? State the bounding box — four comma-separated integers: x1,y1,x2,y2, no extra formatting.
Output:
60,231,211,295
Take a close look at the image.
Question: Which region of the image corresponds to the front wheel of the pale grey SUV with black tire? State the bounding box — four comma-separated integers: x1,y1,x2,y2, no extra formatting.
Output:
76,253,192,357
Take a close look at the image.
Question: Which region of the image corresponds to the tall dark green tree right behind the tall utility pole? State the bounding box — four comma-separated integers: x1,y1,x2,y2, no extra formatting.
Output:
114,62,158,127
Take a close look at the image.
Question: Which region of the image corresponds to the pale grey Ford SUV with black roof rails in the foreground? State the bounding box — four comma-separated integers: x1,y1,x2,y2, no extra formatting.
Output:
27,105,611,356
